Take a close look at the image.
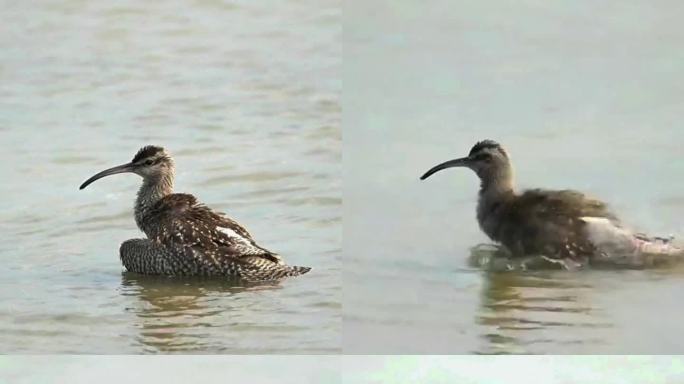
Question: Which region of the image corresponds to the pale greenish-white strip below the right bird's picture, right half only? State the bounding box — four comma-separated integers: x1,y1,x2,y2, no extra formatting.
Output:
343,356,684,384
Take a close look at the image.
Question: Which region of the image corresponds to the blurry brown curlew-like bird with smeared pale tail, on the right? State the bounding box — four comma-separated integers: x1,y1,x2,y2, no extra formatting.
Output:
421,140,684,267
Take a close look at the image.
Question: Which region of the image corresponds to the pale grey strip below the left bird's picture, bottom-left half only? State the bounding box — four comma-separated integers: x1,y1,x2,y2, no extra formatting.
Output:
0,355,340,384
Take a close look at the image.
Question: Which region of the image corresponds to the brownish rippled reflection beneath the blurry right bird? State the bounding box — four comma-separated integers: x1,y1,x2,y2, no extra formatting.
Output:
476,271,611,353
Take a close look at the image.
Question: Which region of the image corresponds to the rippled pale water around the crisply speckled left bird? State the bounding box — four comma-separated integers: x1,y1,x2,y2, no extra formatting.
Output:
0,0,341,353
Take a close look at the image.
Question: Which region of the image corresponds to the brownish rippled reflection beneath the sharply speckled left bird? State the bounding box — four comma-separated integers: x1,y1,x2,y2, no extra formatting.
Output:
121,273,280,353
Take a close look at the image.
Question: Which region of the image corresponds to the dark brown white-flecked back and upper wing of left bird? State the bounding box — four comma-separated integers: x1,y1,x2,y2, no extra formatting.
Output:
147,193,282,264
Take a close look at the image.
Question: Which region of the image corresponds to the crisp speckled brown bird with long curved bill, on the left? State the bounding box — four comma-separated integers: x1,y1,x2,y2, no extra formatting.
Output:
80,146,311,281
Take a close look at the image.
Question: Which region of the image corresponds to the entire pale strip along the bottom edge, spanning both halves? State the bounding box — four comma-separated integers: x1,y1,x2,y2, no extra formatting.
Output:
0,355,684,384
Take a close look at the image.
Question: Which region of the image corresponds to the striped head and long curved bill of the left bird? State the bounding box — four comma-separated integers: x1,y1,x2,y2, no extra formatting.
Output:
79,145,173,189
